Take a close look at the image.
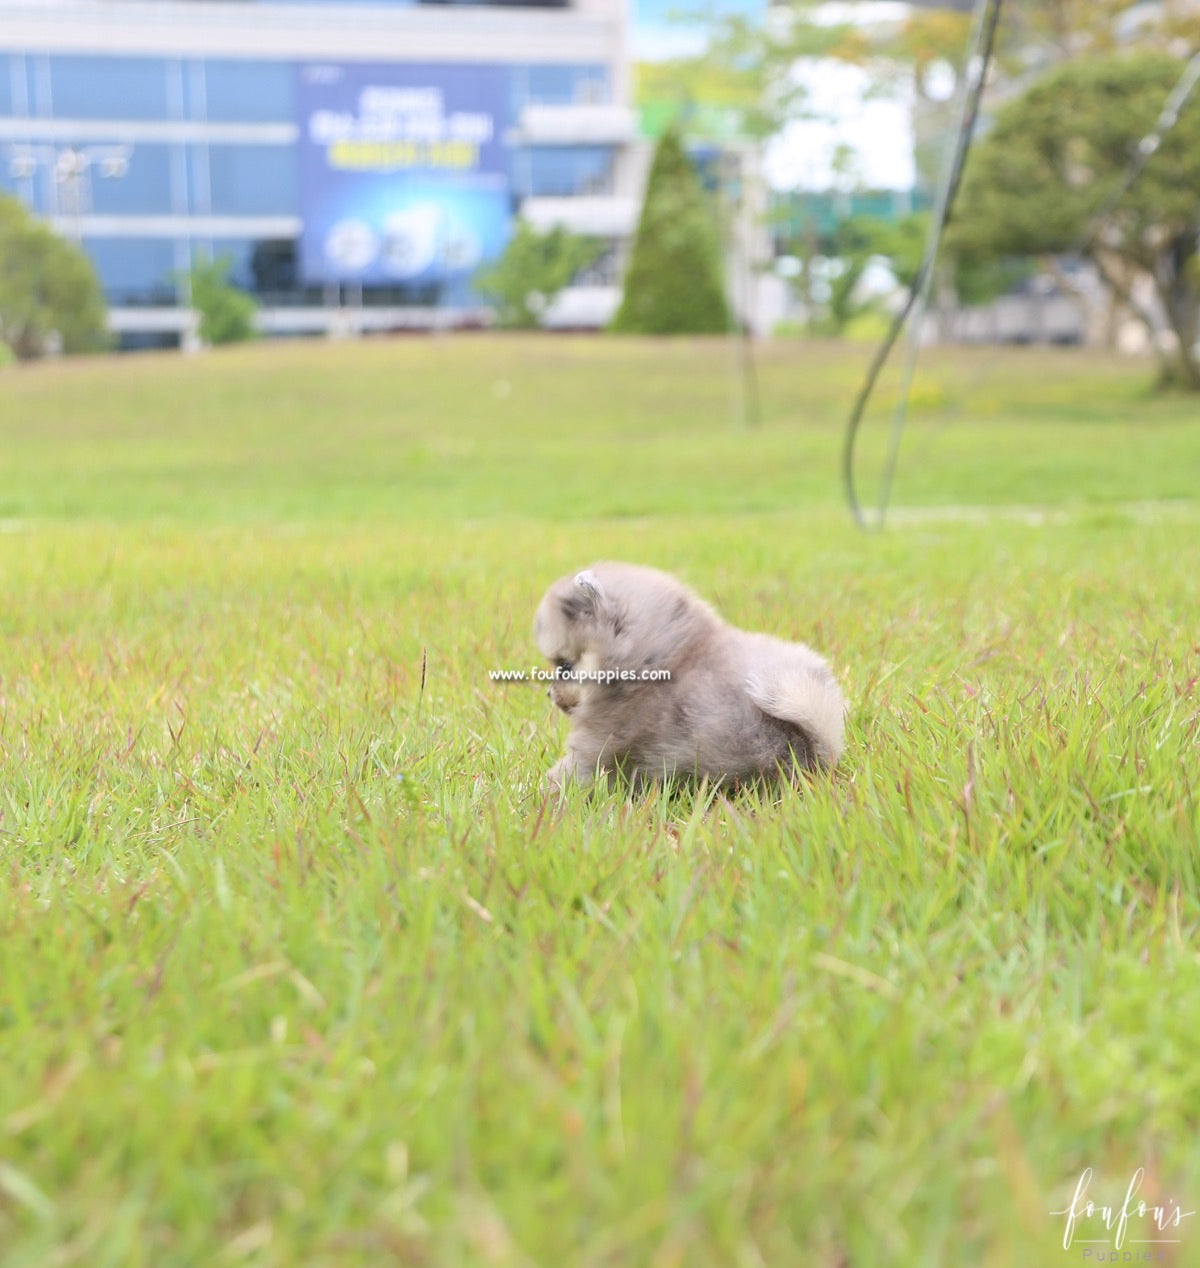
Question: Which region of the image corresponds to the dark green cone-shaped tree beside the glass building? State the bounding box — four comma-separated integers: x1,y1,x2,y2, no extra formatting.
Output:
613,129,729,335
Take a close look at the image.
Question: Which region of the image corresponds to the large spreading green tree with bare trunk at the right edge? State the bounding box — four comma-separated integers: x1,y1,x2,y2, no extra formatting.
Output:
948,52,1200,391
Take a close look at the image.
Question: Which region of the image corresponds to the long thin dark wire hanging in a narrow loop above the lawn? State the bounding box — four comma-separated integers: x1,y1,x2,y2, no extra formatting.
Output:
842,0,1003,530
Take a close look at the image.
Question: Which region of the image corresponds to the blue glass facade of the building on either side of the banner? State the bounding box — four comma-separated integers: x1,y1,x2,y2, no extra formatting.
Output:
0,46,614,327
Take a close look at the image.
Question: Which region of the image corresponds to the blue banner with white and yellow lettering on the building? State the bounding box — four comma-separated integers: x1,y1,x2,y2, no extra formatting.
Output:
296,62,511,287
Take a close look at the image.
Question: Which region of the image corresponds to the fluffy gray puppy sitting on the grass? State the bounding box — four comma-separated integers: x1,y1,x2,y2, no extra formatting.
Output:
534,563,846,787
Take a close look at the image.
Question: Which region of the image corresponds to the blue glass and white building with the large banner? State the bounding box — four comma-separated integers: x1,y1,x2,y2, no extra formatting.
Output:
0,0,641,346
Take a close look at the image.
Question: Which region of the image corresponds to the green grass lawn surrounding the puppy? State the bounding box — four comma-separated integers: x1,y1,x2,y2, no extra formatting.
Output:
0,337,1200,1268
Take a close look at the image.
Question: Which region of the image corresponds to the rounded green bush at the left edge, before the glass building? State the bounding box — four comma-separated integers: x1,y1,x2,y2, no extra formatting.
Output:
0,197,108,360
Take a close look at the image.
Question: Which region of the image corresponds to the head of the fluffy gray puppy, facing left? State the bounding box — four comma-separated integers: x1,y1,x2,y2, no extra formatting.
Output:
533,568,614,714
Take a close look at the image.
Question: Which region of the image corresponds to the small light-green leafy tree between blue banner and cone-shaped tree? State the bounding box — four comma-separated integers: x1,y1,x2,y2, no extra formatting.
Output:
474,221,603,330
